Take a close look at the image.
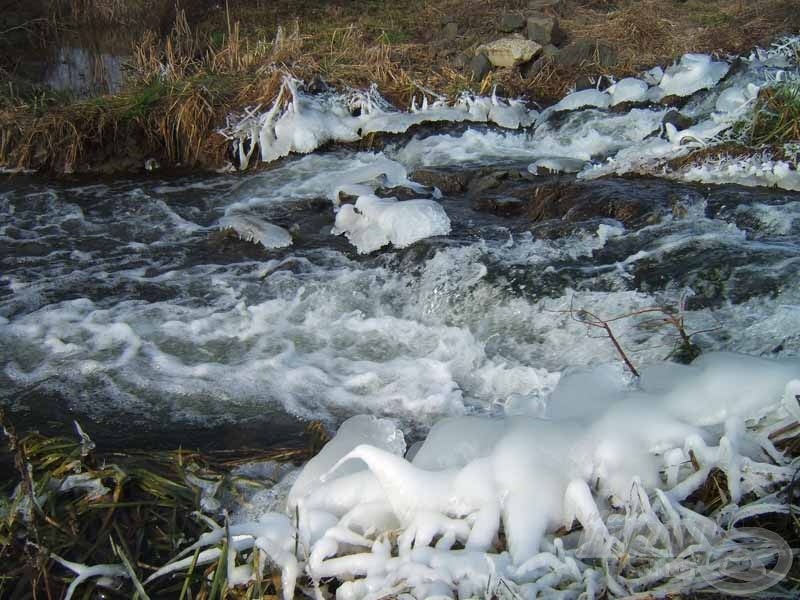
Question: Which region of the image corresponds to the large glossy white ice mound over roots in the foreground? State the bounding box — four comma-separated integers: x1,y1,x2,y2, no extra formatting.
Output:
153,354,800,599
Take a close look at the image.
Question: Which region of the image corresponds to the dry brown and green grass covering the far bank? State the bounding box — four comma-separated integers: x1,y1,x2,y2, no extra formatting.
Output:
0,0,800,173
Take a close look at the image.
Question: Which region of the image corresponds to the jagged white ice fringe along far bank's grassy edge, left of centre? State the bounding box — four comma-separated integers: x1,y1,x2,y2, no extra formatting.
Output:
220,77,538,170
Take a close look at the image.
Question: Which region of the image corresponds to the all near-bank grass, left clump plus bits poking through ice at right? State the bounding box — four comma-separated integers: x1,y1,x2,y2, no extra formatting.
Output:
0,410,800,600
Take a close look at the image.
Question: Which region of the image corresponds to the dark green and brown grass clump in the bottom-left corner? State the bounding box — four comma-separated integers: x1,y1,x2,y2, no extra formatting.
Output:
0,416,310,599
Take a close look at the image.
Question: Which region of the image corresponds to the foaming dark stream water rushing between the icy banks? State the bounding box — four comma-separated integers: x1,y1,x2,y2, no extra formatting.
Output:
0,131,800,445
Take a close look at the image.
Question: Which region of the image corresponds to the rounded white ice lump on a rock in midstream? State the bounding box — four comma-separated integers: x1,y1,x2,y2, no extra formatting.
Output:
333,195,450,254
